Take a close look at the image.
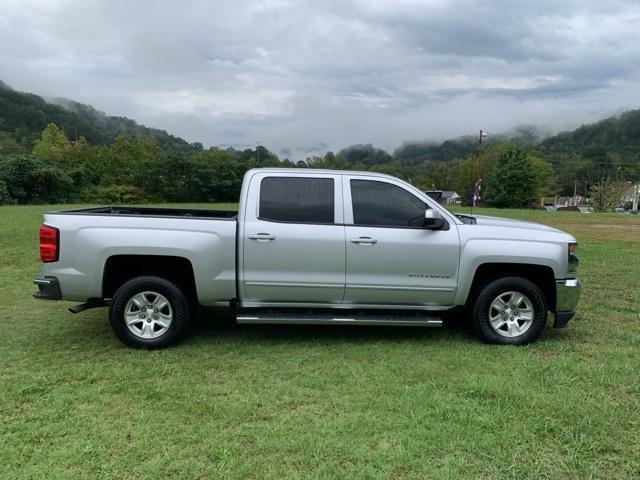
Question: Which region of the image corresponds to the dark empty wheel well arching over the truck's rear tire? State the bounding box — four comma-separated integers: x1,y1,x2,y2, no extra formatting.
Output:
102,255,197,300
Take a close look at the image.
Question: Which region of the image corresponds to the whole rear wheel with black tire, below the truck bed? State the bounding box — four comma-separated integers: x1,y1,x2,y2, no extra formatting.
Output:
109,276,192,349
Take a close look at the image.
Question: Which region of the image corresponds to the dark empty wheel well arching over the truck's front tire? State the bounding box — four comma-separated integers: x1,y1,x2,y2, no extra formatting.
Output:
468,263,556,311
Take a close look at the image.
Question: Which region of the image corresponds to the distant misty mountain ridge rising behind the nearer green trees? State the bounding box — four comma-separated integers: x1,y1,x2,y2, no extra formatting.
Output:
0,80,640,165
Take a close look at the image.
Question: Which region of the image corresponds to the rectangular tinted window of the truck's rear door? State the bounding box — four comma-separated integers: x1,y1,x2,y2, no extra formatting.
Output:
258,177,334,223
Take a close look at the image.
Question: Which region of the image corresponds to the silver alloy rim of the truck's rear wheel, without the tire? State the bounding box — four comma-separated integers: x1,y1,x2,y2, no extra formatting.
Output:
124,291,173,338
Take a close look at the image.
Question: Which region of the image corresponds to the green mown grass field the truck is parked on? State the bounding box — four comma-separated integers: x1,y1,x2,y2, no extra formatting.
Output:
0,206,640,480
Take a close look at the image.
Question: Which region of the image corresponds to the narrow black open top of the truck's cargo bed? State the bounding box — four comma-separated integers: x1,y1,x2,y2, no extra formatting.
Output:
50,205,238,220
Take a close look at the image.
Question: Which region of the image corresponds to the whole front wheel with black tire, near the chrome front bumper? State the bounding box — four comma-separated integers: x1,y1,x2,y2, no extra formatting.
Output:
471,277,547,345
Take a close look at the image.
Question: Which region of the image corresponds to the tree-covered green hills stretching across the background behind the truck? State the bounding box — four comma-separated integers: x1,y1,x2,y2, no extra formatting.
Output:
0,82,640,209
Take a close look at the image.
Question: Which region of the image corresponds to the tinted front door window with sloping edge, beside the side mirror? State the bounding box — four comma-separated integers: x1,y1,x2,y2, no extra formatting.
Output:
351,180,427,227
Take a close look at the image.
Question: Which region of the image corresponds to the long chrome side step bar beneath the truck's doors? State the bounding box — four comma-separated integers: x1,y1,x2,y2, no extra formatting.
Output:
236,312,442,327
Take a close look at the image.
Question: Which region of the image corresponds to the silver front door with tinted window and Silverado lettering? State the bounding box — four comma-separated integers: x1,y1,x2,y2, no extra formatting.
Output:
343,176,460,306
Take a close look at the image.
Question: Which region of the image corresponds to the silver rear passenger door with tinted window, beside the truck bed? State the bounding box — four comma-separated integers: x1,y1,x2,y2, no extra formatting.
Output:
240,172,345,304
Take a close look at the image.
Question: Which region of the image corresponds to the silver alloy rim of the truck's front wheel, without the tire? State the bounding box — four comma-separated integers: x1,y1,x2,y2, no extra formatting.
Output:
489,291,534,338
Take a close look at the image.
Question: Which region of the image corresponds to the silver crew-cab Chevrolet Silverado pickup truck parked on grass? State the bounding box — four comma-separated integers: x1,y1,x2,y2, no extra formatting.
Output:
34,169,580,348
